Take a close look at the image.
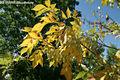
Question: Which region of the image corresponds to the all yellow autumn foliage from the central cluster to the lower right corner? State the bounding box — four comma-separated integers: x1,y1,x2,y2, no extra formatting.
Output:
0,0,120,80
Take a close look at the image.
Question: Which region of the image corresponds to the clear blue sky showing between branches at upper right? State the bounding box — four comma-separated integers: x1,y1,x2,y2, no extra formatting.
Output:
76,0,120,55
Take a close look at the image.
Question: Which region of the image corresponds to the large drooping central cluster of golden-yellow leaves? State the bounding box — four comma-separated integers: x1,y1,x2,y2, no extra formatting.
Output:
20,0,120,80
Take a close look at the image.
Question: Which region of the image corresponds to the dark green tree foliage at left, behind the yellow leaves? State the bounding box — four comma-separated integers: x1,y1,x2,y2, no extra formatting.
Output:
0,0,78,79
